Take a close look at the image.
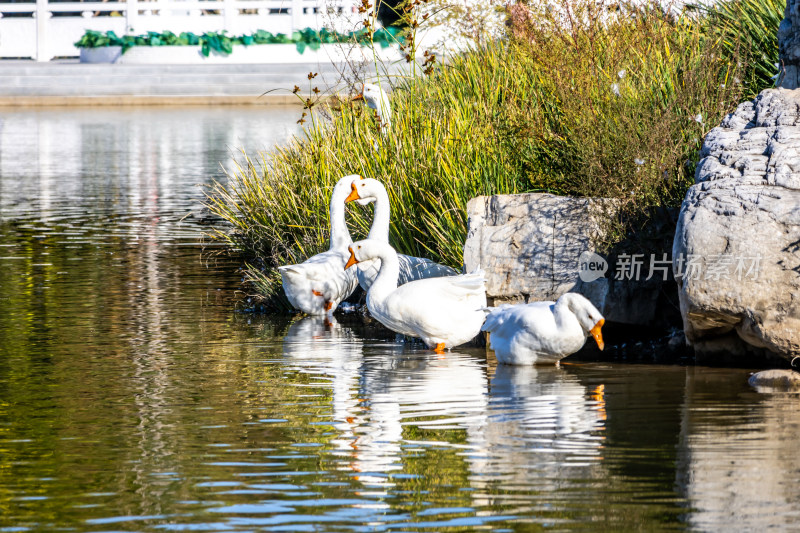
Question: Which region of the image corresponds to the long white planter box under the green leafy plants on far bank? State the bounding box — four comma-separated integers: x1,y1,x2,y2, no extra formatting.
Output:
81,44,402,65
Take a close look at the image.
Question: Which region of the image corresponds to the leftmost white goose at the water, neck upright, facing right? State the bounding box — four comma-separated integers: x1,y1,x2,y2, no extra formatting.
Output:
278,174,359,315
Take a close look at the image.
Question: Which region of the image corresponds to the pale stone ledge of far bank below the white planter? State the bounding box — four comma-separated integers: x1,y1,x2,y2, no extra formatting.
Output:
0,59,397,106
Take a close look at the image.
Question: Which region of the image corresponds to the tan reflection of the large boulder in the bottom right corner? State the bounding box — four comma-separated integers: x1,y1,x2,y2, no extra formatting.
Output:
677,369,800,531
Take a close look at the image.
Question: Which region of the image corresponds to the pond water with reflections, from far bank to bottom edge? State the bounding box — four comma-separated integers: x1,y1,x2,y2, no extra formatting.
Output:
0,108,800,532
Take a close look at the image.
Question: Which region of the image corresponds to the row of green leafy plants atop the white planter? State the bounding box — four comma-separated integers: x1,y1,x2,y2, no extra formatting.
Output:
75,28,402,57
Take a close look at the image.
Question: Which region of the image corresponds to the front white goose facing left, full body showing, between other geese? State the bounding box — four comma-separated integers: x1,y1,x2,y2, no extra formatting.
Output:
345,239,486,353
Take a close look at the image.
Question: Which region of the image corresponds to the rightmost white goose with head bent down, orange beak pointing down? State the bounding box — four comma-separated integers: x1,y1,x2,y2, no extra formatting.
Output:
481,292,605,365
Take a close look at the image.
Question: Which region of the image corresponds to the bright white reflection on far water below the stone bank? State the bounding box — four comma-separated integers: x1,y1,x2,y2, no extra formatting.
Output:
0,107,297,240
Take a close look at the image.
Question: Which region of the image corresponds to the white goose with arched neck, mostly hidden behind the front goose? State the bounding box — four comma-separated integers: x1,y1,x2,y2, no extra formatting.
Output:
345,176,458,291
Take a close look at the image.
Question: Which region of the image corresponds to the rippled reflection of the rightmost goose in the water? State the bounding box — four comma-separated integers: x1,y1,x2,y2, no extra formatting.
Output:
469,365,606,490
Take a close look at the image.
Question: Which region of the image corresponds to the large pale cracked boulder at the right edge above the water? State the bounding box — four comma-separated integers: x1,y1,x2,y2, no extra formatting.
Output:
672,89,800,360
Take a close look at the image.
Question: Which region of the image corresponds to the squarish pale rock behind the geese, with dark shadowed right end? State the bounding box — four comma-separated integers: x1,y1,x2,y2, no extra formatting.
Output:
464,193,674,326
